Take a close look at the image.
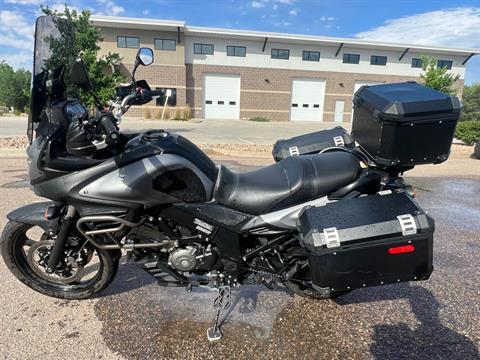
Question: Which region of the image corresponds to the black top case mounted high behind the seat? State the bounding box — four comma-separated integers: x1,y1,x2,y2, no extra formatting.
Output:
352,81,461,167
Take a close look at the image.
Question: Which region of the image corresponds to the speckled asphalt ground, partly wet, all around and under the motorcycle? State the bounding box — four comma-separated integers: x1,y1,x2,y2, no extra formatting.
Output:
0,159,480,359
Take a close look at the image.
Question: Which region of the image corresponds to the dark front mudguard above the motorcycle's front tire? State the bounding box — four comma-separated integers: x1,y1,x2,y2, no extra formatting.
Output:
7,201,60,233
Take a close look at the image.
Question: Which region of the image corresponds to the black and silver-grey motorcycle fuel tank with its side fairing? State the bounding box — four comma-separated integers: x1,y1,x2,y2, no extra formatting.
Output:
34,130,217,207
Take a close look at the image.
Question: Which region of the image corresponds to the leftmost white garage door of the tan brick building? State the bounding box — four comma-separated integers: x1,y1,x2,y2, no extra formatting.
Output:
203,74,240,120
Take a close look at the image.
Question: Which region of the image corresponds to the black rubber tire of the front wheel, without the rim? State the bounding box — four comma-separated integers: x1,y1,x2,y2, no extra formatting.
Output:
1,221,121,300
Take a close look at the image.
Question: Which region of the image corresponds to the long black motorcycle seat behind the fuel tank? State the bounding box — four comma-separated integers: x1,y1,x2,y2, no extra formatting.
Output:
213,152,361,215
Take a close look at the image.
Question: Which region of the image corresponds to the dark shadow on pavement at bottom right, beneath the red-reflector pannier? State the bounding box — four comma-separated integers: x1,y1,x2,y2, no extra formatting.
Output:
336,284,480,360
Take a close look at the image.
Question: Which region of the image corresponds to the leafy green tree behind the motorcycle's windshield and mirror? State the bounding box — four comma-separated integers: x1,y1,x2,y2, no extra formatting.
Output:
41,6,125,107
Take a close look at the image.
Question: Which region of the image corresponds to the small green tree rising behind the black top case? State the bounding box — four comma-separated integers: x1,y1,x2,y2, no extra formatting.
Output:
420,57,460,95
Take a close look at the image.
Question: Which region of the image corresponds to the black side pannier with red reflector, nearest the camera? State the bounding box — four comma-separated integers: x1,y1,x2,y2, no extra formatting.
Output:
299,192,434,294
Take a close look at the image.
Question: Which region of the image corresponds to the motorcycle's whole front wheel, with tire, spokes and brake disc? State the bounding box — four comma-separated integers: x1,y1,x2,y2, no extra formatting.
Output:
1,221,121,300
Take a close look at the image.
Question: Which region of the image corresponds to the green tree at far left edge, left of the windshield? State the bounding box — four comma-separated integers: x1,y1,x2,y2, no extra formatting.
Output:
0,61,32,112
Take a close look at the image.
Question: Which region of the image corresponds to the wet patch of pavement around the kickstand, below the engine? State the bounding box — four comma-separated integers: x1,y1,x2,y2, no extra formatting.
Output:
95,264,293,358
